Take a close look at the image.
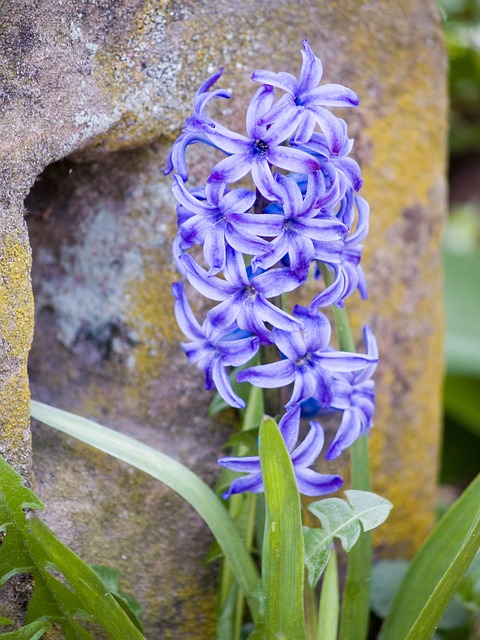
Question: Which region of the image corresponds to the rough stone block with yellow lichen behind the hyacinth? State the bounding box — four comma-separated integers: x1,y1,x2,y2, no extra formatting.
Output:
0,0,446,640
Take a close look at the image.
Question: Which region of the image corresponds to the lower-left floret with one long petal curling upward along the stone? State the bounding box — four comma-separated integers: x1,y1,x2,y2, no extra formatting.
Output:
172,282,260,408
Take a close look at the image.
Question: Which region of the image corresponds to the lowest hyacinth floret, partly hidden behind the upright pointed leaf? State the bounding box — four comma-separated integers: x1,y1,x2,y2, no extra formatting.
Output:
218,406,343,499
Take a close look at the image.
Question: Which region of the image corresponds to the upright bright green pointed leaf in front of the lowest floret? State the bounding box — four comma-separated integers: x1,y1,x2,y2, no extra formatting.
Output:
259,417,306,640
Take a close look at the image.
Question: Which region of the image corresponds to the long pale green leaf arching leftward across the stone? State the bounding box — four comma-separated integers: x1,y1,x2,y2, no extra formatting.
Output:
30,400,260,618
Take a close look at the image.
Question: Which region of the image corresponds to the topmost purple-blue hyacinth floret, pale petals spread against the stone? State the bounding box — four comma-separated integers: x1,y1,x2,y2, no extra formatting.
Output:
252,40,359,151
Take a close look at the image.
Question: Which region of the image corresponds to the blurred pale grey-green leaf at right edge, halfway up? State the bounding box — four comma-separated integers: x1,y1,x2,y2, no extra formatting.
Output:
443,249,480,376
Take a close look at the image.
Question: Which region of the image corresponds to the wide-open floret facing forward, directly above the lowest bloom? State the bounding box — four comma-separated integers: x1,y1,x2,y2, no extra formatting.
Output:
237,306,377,408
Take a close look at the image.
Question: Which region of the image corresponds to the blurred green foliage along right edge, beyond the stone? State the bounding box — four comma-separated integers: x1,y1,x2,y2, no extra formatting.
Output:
439,0,480,486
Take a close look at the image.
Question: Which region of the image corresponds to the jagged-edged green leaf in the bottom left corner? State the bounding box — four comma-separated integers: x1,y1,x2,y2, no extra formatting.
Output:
0,458,143,640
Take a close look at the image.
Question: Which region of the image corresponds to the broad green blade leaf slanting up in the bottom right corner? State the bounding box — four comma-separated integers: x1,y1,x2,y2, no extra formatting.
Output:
379,475,480,640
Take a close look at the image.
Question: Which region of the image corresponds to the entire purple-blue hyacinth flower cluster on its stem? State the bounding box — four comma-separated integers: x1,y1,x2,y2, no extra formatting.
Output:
165,40,378,497
